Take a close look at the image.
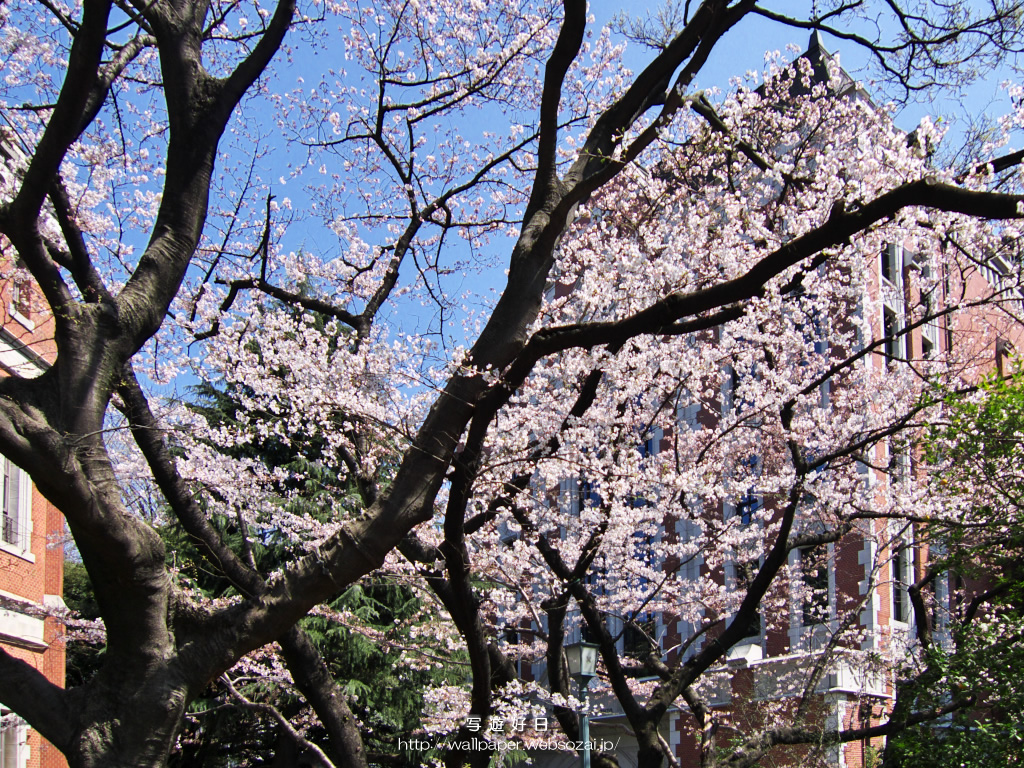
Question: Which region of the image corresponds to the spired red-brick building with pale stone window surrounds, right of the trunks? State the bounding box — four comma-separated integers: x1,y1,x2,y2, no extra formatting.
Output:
529,35,1024,768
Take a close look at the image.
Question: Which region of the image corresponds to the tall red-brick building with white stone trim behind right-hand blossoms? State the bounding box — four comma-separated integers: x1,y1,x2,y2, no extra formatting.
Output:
528,36,1024,768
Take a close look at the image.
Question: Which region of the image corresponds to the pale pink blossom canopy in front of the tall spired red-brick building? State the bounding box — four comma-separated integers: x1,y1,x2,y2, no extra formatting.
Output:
477,69,1020,765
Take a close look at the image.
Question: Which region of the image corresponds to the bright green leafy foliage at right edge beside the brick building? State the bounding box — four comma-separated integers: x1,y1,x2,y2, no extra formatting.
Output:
886,372,1024,768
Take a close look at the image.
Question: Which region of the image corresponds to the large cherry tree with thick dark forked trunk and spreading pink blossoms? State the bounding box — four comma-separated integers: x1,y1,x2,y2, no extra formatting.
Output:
0,0,1022,766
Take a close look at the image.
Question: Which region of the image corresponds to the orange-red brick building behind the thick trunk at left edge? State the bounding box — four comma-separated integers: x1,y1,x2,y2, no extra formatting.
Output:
0,132,67,768
